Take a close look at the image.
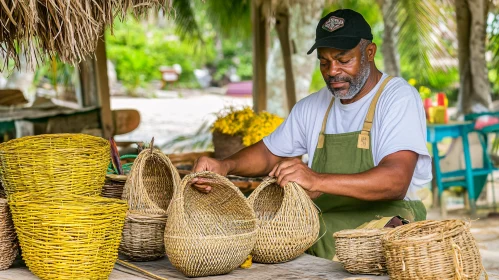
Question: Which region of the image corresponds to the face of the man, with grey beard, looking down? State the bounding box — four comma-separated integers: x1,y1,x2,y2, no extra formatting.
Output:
317,45,371,99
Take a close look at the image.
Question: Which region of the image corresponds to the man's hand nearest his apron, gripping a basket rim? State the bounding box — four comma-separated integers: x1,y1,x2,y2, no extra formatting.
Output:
269,158,321,192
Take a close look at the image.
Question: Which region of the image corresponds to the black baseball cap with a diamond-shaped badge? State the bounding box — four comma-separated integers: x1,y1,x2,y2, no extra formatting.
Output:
307,9,373,54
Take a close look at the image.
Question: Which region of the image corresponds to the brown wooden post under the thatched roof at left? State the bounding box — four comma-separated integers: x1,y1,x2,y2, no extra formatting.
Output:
95,34,114,138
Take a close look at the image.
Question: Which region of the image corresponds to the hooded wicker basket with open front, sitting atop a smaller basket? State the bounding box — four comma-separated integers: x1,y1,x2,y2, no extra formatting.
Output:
123,149,180,215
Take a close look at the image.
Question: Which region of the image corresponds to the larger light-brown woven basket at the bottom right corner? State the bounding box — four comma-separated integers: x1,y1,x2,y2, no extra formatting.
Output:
383,220,483,280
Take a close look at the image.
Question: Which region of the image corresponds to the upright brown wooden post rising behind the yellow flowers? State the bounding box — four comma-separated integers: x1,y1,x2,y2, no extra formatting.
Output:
251,0,269,112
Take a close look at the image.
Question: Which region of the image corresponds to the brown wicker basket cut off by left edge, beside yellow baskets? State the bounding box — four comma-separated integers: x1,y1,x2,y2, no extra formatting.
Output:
0,198,17,270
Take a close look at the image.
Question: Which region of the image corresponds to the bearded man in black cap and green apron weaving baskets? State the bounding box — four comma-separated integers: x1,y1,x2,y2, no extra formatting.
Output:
193,10,432,259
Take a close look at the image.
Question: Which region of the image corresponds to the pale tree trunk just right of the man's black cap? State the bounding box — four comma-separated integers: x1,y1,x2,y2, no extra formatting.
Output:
378,0,400,77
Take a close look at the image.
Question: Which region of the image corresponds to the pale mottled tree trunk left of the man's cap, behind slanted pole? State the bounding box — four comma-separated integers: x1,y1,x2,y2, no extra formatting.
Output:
267,0,325,117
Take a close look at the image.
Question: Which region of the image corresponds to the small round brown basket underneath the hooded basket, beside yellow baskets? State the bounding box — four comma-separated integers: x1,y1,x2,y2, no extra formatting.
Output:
119,212,166,261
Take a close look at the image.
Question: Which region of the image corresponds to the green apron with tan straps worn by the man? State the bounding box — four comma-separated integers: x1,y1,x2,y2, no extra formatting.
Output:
307,77,426,260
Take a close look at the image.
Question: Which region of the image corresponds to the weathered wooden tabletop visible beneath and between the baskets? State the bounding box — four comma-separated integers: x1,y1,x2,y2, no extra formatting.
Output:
0,254,388,280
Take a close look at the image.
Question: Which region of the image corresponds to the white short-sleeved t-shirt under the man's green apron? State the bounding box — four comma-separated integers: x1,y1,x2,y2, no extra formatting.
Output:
263,74,432,200
